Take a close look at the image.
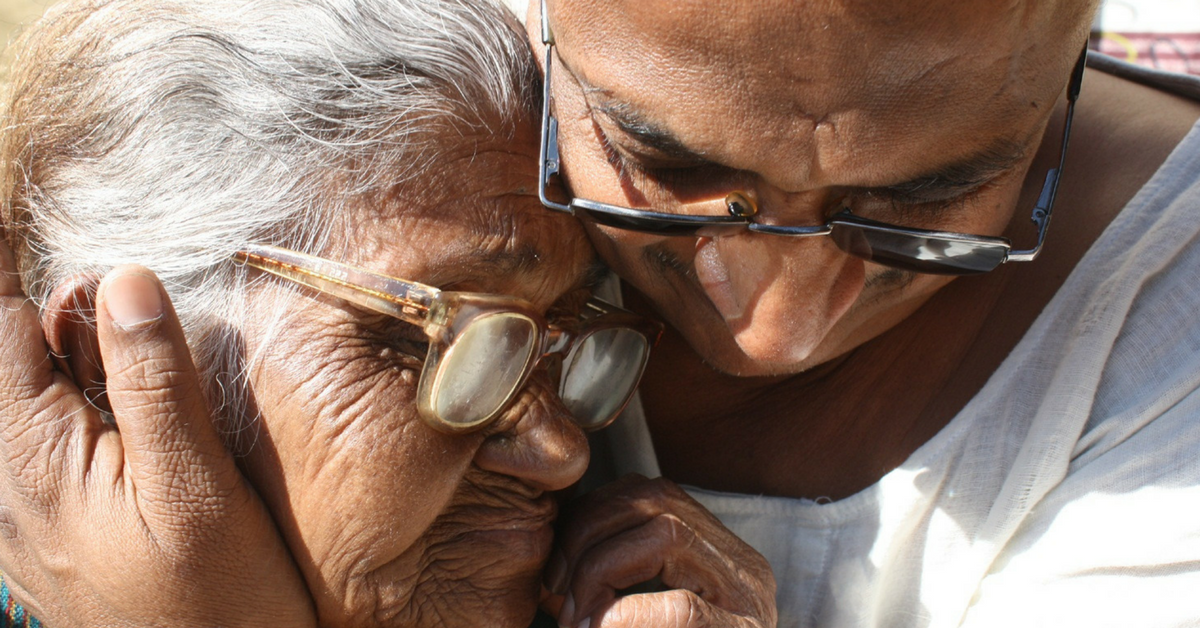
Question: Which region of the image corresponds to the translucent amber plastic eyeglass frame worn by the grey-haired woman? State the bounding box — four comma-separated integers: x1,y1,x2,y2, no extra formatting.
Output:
233,245,662,433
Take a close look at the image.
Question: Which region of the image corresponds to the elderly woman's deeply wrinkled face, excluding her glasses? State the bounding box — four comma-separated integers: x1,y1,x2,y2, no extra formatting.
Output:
236,126,593,627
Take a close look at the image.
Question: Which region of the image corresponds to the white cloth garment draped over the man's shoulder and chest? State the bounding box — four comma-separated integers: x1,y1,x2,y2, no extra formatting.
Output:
595,57,1200,628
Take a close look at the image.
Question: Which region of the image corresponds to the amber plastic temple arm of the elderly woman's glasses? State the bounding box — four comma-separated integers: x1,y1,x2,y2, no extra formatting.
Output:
234,245,440,325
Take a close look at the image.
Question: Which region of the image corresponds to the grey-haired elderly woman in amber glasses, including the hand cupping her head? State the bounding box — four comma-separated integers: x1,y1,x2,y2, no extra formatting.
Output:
0,0,656,626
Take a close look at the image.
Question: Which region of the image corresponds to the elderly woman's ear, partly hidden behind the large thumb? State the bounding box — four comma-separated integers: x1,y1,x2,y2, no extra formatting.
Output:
42,275,113,414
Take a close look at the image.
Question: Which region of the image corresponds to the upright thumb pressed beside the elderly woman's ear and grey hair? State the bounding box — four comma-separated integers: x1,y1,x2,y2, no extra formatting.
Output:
96,267,240,520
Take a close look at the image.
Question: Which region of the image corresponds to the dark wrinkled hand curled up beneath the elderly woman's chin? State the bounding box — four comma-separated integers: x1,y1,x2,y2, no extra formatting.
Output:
542,476,776,628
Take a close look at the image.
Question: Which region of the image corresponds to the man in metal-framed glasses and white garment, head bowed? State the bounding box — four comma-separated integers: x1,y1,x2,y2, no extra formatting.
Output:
527,0,1200,628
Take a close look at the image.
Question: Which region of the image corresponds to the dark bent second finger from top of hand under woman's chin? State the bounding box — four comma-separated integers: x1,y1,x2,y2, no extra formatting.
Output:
560,514,734,626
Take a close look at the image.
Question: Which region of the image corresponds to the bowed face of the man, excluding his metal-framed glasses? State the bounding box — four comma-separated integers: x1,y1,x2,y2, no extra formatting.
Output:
529,0,1091,375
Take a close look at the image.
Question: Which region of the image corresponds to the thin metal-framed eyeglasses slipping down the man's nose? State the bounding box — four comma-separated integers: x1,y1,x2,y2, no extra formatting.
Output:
538,0,1087,275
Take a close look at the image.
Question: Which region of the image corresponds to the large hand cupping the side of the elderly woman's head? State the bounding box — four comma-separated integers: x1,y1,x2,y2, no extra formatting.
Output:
0,240,316,627
